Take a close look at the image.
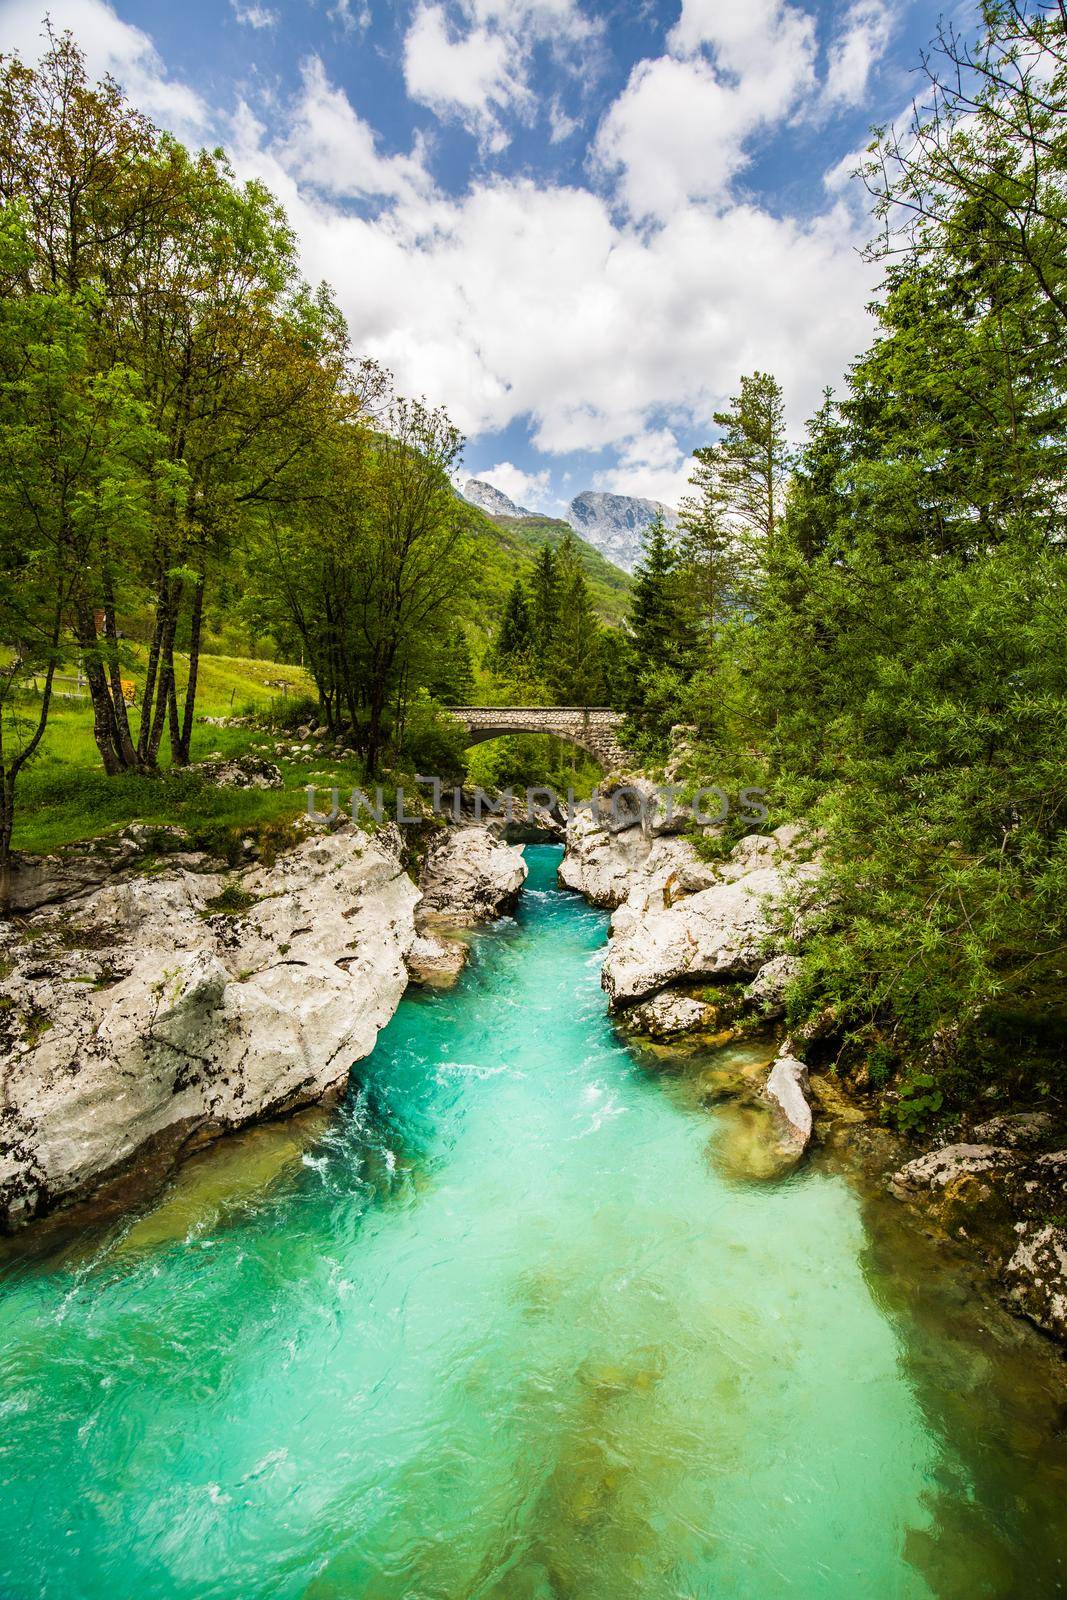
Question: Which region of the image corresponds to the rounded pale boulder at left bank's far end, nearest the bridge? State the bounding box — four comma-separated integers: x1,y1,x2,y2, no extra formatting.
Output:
419,827,526,928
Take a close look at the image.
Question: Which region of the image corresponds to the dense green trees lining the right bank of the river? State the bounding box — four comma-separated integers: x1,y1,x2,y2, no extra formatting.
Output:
624,0,1067,1122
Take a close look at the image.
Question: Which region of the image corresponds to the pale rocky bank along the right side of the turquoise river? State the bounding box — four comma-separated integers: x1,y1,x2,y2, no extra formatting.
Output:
560,778,1067,1341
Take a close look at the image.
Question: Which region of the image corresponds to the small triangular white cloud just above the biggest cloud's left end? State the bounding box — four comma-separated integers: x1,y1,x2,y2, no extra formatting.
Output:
278,56,429,198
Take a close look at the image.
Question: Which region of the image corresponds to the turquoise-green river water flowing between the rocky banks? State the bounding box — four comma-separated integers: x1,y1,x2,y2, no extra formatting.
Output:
0,846,1067,1600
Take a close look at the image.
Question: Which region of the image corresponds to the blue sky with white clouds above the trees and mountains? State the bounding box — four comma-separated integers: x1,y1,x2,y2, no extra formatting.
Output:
0,0,968,510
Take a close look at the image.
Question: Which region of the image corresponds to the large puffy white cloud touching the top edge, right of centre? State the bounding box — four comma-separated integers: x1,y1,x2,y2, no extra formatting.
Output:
595,0,816,219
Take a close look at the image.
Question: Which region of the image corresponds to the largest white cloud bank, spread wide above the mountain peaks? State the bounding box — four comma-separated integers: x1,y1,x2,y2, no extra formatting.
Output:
237,162,872,454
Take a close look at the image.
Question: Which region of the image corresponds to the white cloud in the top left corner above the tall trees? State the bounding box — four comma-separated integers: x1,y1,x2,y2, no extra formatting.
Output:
0,0,210,139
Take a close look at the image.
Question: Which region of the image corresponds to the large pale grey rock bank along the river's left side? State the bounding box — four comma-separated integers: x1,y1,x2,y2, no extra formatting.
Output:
0,824,525,1229
